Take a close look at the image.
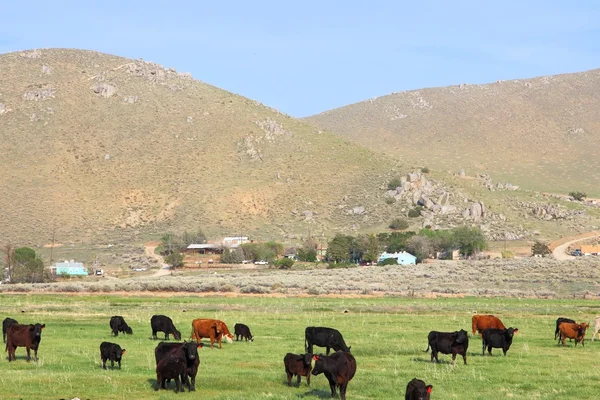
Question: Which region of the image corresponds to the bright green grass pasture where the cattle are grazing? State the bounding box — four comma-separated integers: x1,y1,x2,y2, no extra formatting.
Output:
0,294,600,400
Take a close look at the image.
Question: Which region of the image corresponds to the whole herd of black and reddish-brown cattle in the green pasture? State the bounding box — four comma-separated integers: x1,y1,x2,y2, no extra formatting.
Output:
2,315,600,400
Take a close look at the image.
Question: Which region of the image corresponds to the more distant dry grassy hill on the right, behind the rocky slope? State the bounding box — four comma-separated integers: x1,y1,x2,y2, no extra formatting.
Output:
306,70,600,197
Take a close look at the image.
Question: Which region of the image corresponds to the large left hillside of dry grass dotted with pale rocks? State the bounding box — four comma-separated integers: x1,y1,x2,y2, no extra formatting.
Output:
0,49,410,245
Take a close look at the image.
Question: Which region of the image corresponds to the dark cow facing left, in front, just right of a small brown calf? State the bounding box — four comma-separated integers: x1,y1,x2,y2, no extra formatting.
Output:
312,351,356,400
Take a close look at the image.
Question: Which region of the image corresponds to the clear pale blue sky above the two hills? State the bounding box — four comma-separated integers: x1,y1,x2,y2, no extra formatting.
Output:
0,0,600,117
